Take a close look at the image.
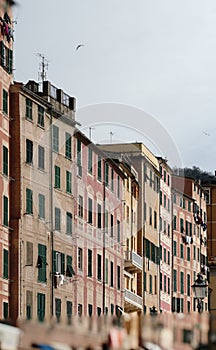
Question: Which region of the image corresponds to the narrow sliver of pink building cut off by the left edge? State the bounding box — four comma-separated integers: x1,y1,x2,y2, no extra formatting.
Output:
0,0,14,318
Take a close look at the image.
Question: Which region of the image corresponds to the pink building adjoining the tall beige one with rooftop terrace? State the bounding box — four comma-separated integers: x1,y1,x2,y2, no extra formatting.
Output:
72,131,124,316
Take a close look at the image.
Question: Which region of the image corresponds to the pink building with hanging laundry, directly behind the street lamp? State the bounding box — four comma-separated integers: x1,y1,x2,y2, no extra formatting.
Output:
172,175,208,313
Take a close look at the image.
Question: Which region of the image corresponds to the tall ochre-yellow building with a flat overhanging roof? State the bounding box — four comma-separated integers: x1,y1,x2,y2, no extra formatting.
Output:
100,143,161,313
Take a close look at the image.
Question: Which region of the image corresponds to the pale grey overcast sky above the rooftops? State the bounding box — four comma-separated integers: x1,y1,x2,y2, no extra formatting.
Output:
14,0,216,172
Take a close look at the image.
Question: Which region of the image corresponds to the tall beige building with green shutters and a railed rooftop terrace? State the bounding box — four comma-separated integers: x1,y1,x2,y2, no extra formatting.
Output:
9,81,76,321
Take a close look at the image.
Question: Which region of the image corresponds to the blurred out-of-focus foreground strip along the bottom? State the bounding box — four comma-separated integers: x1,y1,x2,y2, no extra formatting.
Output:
0,313,216,350
